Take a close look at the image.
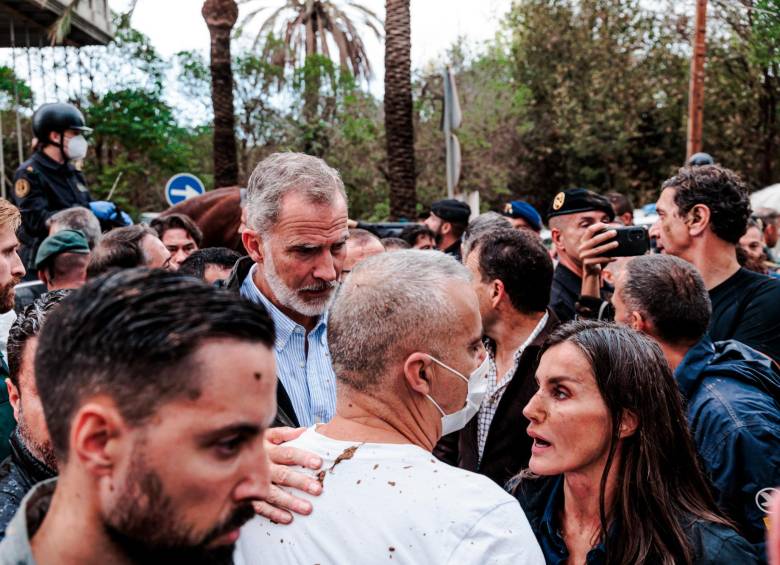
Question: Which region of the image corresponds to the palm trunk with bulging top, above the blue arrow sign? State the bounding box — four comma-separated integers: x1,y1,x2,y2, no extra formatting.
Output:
201,0,238,188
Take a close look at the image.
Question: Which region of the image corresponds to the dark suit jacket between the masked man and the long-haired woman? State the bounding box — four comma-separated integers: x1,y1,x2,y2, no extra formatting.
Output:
434,309,560,488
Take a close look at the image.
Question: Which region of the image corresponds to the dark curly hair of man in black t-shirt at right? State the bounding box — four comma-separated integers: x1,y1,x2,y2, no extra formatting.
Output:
662,165,750,245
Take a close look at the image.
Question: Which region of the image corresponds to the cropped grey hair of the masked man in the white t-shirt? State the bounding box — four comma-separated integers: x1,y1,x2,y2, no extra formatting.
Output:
328,249,471,391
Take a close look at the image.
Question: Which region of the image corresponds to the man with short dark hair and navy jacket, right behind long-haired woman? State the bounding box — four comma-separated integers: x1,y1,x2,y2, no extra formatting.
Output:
612,255,780,556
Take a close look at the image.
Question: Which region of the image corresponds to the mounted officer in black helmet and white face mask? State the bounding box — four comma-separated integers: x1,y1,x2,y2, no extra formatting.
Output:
12,103,92,278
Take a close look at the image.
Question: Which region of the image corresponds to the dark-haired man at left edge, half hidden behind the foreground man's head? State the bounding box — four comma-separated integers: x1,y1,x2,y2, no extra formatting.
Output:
0,290,71,540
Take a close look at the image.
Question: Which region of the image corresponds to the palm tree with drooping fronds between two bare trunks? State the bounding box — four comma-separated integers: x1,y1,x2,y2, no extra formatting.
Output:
238,0,382,122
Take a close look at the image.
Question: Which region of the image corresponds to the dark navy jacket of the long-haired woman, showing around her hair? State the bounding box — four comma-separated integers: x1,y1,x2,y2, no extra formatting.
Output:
510,475,758,565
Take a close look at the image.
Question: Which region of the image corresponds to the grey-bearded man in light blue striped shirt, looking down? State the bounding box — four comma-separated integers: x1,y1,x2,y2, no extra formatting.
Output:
225,153,349,427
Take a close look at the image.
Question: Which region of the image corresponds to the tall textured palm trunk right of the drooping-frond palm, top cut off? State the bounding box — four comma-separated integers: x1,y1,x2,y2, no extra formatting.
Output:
385,0,417,220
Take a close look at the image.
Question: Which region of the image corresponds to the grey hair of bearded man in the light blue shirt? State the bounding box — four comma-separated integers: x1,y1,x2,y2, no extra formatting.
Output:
246,153,347,233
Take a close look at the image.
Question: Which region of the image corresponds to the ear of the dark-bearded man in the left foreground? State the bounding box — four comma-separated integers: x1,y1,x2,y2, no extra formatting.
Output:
70,396,129,476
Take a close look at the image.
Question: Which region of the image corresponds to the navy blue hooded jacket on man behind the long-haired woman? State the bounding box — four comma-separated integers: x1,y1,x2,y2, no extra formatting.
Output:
674,336,780,555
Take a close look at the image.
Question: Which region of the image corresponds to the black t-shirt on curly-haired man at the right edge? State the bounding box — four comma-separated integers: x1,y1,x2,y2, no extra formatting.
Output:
710,268,780,361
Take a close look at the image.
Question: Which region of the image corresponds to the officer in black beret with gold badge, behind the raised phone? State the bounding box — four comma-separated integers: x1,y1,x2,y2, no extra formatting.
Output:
547,188,615,322
